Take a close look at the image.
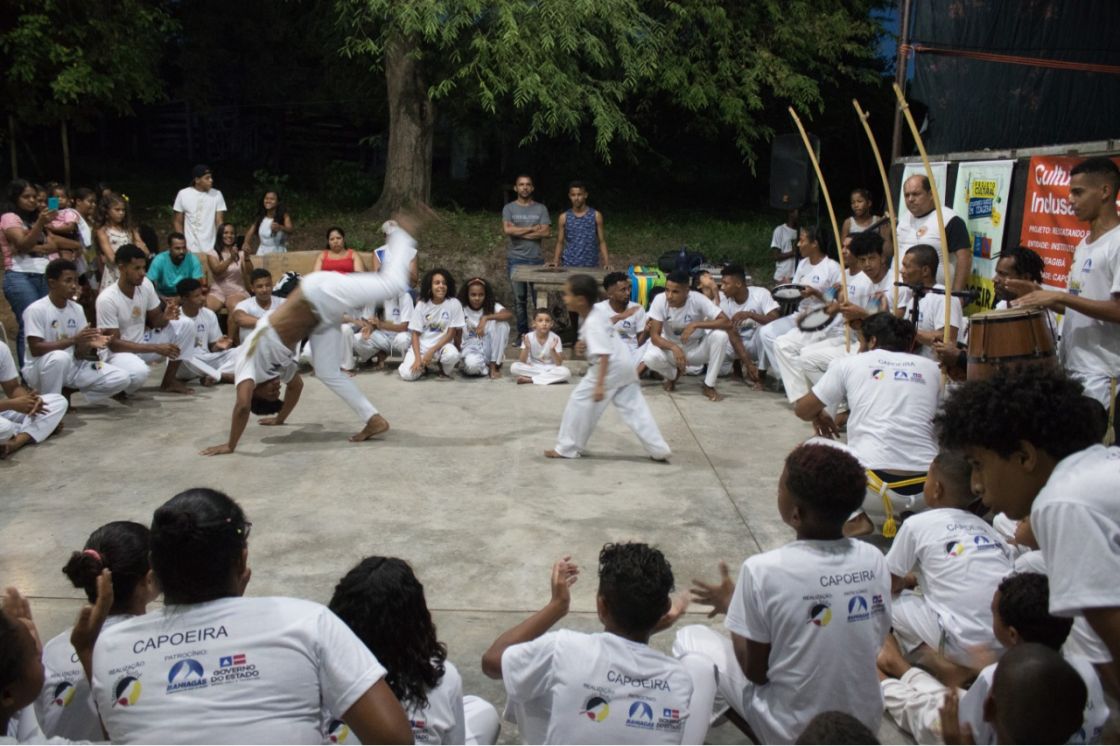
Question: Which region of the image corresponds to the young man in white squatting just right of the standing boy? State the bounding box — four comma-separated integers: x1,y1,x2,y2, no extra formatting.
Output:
642,271,730,401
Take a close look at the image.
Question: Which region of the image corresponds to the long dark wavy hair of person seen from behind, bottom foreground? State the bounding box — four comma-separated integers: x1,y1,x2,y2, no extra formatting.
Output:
329,557,447,709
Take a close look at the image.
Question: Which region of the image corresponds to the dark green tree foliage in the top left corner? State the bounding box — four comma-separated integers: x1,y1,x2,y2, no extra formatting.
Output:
0,0,177,123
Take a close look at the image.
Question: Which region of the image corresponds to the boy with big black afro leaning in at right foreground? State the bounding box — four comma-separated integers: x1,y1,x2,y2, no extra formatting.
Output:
936,367,1120,677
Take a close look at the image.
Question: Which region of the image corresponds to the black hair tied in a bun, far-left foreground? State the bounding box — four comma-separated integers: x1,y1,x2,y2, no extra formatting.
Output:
63,521,151,612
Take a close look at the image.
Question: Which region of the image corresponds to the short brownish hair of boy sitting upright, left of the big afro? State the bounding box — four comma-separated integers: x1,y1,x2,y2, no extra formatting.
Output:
785,442,867,523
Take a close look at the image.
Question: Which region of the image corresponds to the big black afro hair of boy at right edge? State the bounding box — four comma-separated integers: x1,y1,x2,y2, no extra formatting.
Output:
933,366,1100,460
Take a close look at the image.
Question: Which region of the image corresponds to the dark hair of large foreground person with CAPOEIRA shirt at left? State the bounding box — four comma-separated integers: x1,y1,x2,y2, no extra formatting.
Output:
151,487,252,604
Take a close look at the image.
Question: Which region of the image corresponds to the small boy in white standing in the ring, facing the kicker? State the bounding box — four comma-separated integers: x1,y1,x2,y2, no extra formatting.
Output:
544,274,670,461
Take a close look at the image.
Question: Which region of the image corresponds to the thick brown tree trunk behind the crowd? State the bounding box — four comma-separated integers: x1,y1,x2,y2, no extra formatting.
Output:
370,37,436,217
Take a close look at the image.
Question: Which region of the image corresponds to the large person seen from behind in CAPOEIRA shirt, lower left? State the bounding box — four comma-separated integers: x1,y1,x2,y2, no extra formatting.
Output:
86,488,412,744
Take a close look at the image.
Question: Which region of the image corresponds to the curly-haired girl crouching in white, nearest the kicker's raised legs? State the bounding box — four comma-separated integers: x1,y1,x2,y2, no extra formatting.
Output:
396,268,466,381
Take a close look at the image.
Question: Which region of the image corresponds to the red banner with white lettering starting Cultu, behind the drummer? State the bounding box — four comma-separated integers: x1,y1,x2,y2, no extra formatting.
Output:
1019,156,1120,289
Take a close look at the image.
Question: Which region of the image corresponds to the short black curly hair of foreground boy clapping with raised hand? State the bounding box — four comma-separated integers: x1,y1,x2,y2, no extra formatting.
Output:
599,542,673,634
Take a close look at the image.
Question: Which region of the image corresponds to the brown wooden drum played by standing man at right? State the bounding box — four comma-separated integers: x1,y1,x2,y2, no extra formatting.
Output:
968,308,1057,381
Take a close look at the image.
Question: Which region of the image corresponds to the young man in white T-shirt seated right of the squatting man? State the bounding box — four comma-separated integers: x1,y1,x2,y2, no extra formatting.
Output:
719,264,782,389
